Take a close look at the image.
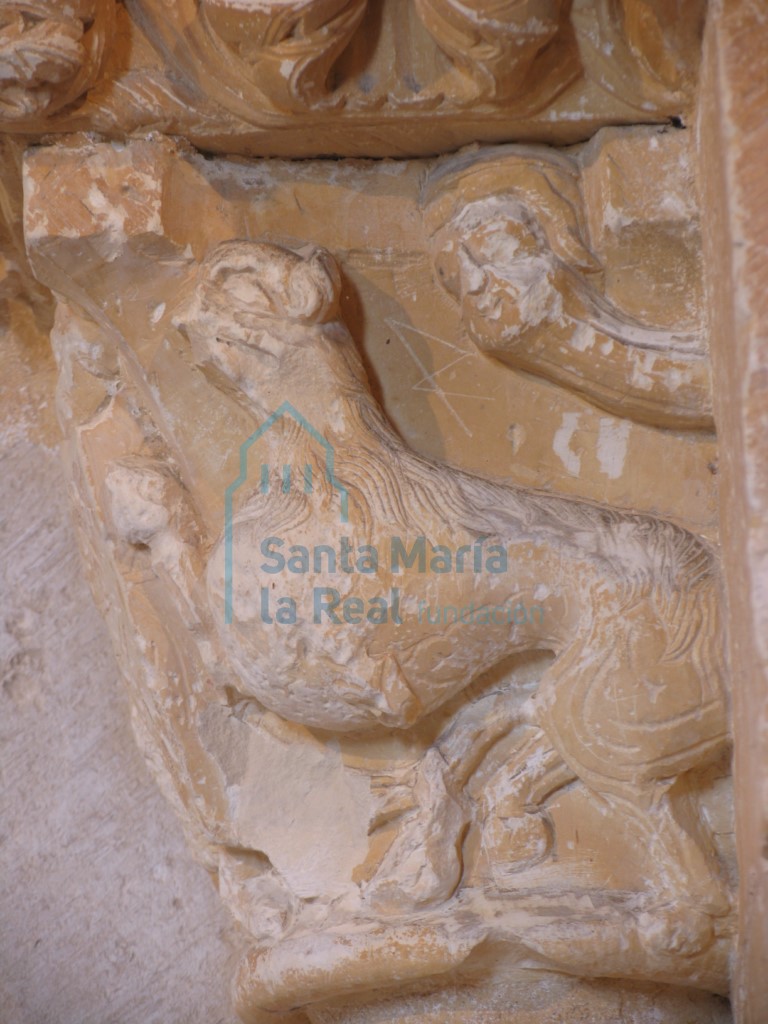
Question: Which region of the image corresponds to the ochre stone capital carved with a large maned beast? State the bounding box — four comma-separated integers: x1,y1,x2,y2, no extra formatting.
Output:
20,131,734,1024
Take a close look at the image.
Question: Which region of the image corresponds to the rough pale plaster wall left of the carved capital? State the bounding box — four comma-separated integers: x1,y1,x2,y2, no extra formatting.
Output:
0,331,246,1024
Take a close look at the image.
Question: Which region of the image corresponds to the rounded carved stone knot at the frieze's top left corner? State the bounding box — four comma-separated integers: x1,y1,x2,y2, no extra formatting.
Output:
0,0,115,129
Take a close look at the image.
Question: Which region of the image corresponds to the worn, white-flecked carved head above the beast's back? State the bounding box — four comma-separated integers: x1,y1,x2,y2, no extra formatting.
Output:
424,147,601,340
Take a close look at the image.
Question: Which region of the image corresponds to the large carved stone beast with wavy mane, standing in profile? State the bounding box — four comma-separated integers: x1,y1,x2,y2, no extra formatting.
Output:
183,243,726,912
